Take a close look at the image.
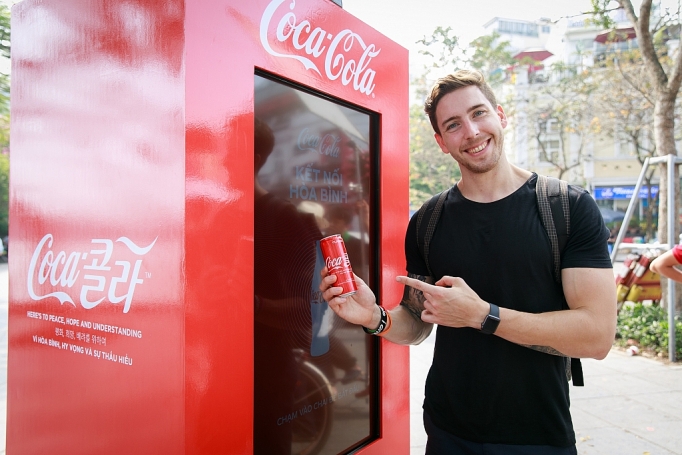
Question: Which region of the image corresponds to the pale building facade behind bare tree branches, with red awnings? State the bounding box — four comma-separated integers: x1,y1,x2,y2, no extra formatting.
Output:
484,10,658,219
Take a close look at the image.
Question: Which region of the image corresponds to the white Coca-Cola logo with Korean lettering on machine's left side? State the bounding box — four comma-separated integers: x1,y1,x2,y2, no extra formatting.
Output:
26,234,157,313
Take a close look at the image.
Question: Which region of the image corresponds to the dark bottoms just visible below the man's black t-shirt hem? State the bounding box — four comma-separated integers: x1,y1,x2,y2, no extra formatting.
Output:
424,411,578,455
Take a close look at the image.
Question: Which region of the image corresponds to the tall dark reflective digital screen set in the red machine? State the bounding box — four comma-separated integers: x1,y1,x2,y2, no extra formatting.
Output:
254,75,377,455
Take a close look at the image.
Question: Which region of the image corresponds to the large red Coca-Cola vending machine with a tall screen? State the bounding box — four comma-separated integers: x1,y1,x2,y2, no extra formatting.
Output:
7,0,409,455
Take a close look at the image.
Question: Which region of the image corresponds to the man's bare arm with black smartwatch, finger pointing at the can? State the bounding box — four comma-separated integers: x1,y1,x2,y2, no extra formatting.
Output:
399,268,616,359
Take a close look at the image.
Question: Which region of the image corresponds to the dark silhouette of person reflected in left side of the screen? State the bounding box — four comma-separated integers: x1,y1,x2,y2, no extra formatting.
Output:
253,118,322,455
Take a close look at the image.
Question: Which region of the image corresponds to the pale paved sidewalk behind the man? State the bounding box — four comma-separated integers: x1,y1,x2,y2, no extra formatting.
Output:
410,331,682,455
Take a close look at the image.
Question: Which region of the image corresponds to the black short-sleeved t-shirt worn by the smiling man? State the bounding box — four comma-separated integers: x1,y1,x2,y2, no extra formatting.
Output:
405,174,611,447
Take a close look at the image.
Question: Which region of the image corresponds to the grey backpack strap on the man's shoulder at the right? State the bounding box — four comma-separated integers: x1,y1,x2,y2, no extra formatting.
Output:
535,175,585,386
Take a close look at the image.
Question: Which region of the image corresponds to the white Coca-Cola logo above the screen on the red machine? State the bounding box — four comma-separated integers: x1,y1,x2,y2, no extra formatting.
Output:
260,0,381,95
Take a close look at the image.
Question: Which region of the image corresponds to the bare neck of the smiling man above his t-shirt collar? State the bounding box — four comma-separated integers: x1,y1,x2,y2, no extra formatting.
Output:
457,163,532,203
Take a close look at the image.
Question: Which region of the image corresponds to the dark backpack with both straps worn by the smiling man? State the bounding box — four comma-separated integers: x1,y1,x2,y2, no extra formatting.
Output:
414,175,585,386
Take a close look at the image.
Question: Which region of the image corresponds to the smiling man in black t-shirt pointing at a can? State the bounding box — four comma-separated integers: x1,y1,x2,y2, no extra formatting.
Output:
320,70,616,455
